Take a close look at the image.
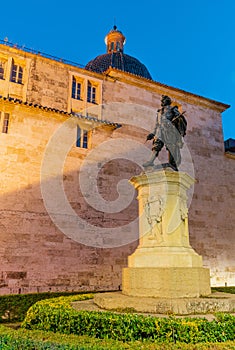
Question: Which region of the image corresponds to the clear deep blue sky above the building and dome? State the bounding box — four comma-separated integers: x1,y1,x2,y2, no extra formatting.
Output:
0,0,235,139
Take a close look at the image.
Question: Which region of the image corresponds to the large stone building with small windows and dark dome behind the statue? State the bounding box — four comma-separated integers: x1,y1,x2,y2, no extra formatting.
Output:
0,28,235,294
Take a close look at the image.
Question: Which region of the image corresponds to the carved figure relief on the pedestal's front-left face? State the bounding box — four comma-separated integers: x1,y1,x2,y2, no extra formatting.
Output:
144,196,165,243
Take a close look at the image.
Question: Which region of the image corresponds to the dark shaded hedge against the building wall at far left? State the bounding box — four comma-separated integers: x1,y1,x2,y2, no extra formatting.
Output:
0,292,91,323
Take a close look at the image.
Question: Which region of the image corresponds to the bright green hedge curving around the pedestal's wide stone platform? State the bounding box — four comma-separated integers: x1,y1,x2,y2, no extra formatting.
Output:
22,295,235,343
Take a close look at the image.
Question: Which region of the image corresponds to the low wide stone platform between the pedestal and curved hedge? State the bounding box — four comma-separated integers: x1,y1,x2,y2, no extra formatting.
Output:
94,292,235,315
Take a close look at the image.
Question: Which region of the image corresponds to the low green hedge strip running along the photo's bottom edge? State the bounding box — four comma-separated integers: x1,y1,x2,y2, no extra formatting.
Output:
0,326,235,350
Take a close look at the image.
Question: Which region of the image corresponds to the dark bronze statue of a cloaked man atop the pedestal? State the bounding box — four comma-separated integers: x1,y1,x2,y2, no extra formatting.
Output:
143,95,187,171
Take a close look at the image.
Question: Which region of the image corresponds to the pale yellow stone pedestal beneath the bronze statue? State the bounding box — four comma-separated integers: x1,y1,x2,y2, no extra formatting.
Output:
122,168,211,298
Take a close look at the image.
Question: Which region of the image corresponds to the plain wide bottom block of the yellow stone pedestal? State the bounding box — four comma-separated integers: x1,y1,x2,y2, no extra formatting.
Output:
122,267,211,298
